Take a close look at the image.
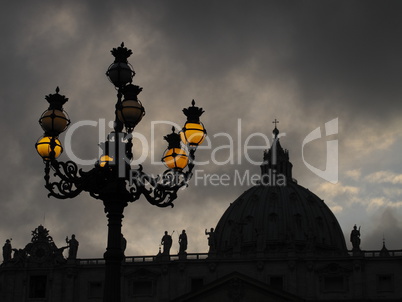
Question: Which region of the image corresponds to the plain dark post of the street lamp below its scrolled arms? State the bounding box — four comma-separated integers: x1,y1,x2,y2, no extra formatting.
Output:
103,199,127,302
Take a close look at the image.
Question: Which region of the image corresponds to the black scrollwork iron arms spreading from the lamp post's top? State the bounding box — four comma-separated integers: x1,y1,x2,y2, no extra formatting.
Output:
44,156,194,207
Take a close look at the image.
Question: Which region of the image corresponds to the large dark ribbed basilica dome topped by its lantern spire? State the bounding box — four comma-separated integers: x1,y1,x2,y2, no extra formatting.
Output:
210,127,347,257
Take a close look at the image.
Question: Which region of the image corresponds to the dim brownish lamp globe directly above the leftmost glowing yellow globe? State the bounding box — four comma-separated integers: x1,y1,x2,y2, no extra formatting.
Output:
39,109,70,136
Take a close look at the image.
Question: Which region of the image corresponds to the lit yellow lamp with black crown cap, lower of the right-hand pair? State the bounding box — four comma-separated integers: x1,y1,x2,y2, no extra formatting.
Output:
162,127,188,170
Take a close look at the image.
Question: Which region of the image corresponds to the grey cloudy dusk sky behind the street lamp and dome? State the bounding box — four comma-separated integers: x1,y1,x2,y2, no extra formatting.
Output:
0,0,402,258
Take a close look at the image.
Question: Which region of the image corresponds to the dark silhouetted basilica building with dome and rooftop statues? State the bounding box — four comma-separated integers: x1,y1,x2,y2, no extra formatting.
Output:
0,127,402,302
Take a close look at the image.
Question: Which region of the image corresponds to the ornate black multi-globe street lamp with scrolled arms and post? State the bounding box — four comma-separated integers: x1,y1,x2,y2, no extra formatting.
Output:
35,43,206,302
